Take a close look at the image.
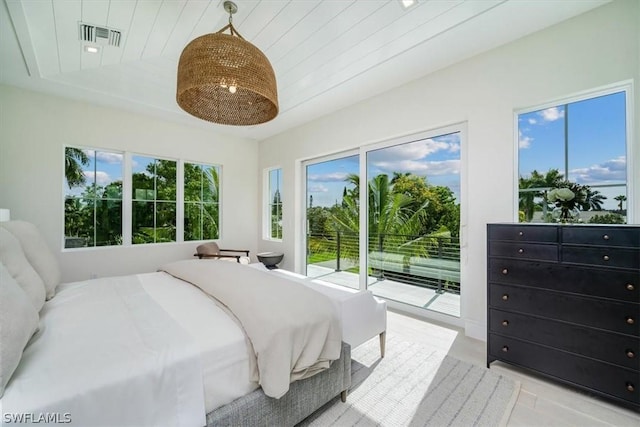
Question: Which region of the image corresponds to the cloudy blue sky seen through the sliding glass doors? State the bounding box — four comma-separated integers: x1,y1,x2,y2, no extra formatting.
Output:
307,133,460,206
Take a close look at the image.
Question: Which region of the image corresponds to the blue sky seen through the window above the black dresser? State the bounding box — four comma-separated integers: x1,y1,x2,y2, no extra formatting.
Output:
518,92,626,209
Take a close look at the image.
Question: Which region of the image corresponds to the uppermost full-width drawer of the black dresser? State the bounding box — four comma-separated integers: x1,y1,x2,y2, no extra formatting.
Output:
488,258,640,303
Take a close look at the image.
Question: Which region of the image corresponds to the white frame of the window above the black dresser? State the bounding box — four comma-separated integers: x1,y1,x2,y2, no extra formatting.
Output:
513,80,638,225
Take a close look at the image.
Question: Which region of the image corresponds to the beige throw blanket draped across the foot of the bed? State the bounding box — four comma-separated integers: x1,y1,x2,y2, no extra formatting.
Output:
162,260,342,398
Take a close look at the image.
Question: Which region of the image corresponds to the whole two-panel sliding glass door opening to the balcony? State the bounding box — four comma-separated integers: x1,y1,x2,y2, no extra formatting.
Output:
304,127,462,317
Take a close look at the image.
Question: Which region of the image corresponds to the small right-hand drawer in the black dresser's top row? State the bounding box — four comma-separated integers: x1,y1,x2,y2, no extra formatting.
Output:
561,226,640,248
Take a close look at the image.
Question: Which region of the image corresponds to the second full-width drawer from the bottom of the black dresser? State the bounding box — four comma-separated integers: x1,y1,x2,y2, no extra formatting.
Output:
489,309,640,370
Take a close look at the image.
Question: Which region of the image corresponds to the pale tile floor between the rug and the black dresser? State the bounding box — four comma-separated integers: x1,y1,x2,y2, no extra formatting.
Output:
384,311,640,427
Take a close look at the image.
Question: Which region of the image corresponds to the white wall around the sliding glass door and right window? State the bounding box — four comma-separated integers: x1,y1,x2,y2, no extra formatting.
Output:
258,0,640,339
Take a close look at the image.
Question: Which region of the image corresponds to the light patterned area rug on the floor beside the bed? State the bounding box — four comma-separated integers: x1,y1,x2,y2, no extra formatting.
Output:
300,337,520,427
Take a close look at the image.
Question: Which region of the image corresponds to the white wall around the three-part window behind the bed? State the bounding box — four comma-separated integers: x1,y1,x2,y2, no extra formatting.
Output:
0,85,259,281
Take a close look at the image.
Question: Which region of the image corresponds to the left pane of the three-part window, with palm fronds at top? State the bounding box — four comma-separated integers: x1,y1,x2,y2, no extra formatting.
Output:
64,147,123,248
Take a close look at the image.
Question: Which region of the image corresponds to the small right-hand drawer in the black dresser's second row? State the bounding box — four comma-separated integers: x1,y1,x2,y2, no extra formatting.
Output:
561,245,640,274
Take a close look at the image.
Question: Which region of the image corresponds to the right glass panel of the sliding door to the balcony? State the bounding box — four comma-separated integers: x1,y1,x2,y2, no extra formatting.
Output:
366,132,460,317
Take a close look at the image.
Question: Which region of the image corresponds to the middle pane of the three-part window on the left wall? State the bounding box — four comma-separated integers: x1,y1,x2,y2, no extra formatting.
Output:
131,156,177,244
